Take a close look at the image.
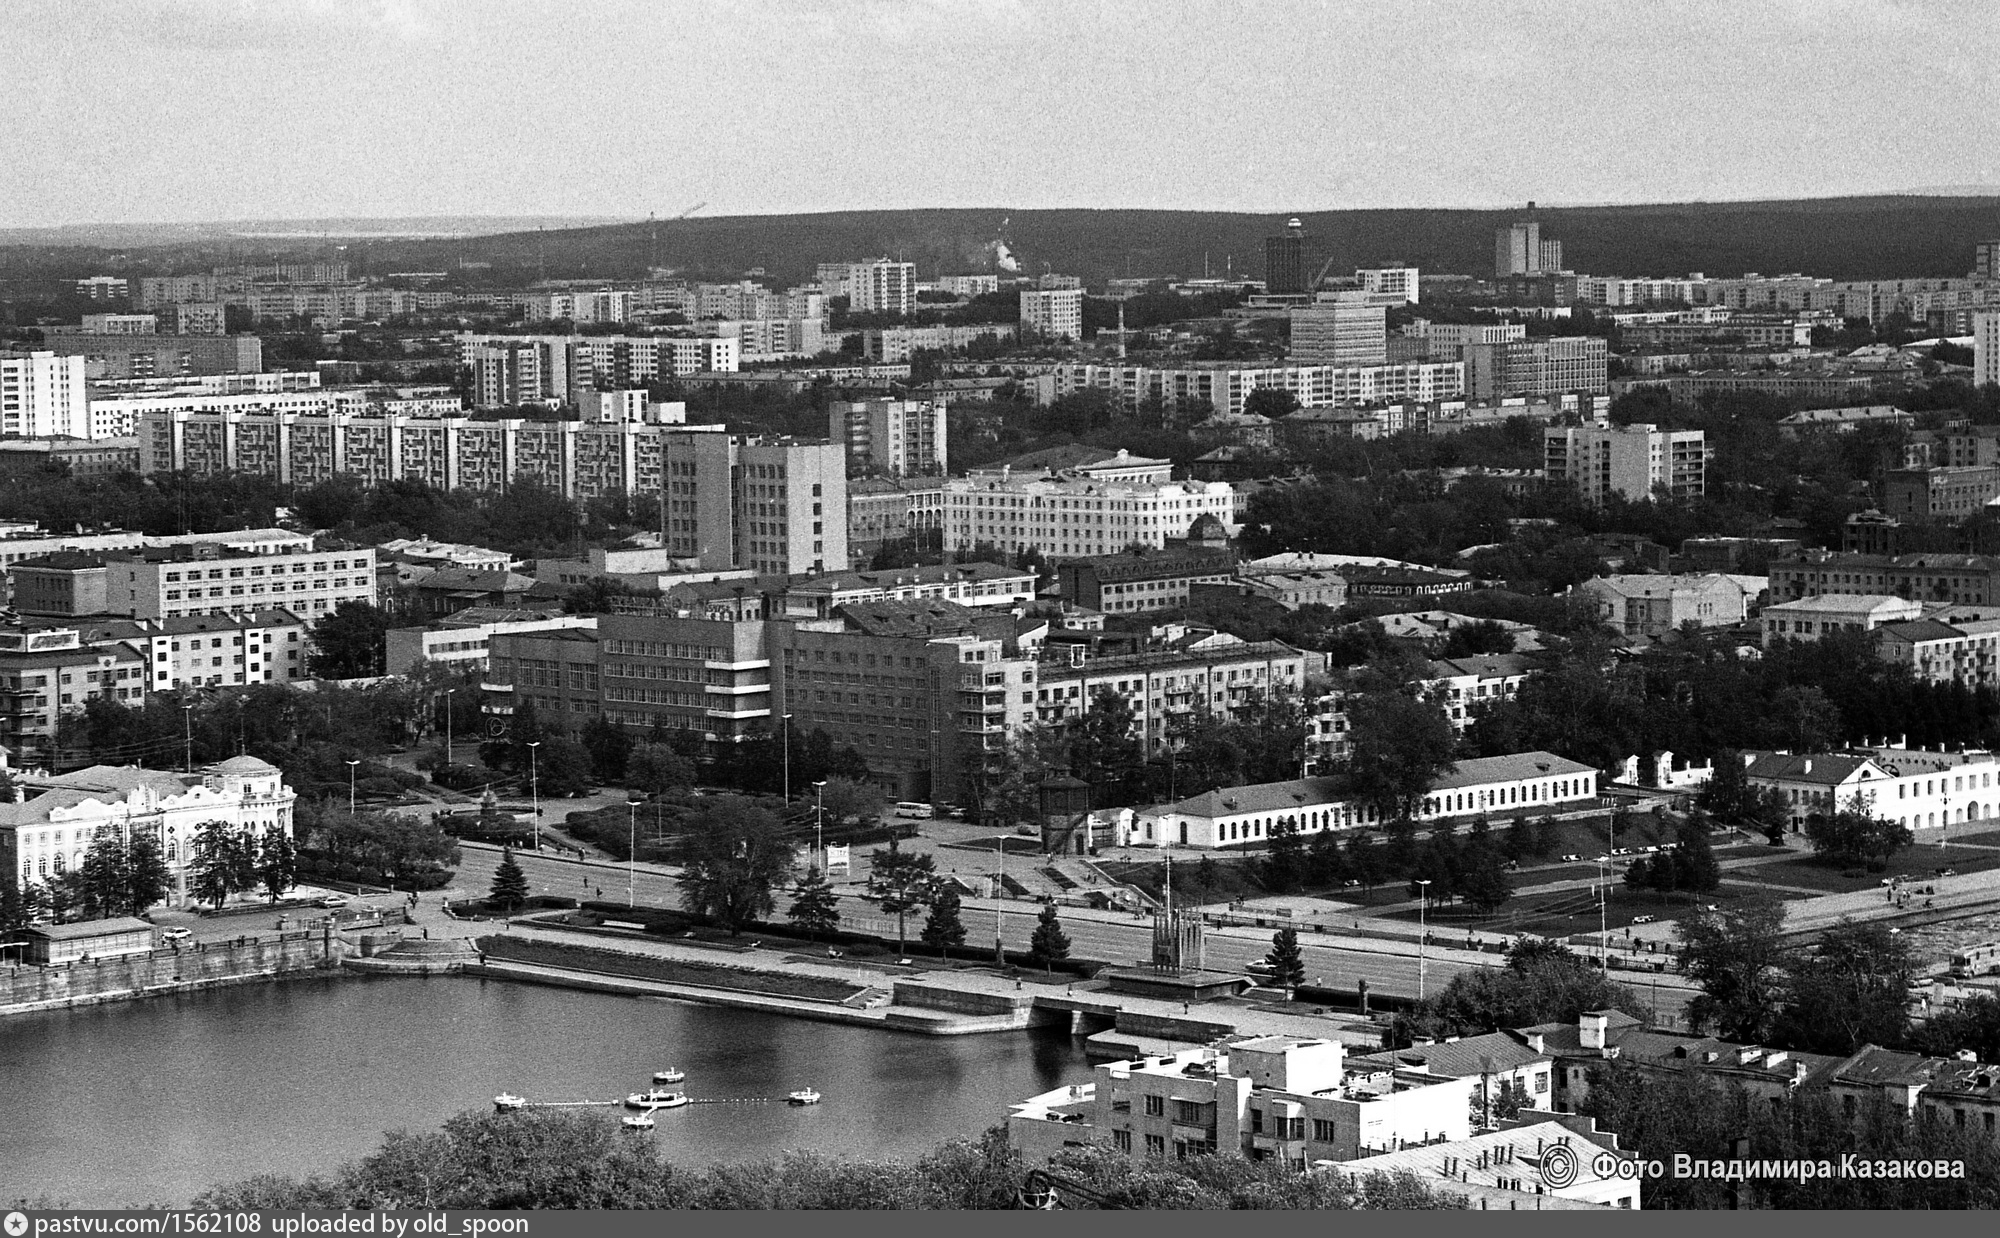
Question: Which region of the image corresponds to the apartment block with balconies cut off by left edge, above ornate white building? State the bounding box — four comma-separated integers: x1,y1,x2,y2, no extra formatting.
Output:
0,624,148,766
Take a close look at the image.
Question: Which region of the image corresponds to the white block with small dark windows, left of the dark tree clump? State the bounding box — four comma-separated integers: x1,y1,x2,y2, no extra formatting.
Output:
90,610,310,692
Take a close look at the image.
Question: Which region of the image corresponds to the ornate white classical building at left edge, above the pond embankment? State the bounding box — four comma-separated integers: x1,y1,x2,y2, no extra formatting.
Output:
0,756,298,906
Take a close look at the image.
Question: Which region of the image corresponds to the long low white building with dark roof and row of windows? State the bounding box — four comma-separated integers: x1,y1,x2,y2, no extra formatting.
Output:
1134,752,1598,846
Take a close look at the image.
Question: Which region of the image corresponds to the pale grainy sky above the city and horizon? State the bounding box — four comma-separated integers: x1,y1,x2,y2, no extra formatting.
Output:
0,0,2000,228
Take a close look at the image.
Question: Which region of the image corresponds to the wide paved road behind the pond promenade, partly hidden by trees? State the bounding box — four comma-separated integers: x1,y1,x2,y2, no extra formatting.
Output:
454,848,1694,1022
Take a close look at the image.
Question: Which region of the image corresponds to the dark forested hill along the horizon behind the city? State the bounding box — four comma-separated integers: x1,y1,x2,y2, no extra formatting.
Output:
348,196,2000,284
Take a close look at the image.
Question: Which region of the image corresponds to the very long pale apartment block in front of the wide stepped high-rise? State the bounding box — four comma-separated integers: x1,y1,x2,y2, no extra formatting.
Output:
1054,362,1466,414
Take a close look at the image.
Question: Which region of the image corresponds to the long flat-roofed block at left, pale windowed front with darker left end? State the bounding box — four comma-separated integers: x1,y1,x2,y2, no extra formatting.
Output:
8,542,376,622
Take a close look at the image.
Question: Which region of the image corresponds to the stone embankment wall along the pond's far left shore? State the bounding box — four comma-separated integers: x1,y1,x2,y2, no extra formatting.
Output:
0,932,352,1014
